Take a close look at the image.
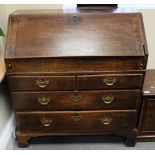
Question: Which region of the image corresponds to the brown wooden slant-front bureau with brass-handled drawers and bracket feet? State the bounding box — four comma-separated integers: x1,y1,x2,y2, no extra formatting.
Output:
5,8,148,147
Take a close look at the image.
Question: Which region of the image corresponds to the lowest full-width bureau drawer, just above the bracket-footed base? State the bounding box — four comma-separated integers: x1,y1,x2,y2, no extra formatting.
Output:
17,110,136,133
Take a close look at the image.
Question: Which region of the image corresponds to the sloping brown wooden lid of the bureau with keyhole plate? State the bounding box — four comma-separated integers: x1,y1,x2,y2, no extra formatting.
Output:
6,12,145,58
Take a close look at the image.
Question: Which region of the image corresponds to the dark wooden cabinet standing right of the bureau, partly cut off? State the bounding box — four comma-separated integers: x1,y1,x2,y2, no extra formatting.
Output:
137,69,155,141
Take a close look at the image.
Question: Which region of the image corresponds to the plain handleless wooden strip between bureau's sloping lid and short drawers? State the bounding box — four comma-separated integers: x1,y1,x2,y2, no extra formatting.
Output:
5,57,146,73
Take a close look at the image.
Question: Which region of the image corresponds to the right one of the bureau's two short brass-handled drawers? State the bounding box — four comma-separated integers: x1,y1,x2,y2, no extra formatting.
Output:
77,74,143,90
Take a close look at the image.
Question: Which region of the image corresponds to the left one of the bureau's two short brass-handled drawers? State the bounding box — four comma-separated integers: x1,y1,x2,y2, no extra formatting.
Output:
8,76,75,91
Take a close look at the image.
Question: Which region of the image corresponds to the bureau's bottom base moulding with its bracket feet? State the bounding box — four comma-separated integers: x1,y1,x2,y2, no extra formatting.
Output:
16,129,137,148
